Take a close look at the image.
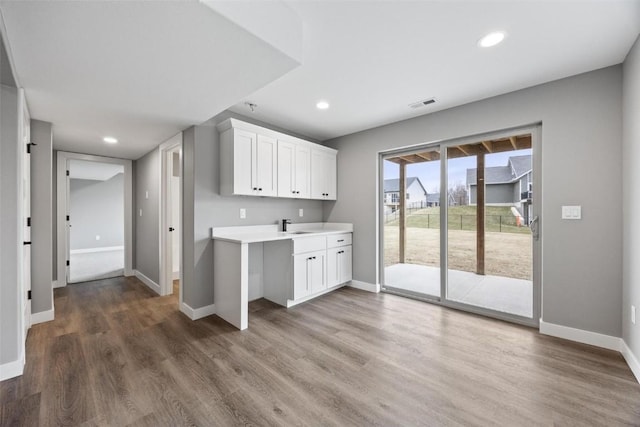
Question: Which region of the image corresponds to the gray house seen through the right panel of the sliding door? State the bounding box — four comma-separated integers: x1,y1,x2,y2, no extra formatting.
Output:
467,154,533,219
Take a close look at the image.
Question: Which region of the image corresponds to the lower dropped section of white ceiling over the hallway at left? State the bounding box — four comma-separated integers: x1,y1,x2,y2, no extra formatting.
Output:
0,0,298,159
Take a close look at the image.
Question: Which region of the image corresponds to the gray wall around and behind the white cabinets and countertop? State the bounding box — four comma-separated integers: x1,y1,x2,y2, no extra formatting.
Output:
183,112,327,308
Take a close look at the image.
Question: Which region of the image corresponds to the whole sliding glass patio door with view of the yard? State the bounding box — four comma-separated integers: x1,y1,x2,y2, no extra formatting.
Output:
380,126,540,325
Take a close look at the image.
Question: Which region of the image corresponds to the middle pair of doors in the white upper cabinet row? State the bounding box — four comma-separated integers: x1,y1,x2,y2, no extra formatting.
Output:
278,141,311,199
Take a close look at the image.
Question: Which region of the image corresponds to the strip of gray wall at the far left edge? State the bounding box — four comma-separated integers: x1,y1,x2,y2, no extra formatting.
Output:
0,85,23,365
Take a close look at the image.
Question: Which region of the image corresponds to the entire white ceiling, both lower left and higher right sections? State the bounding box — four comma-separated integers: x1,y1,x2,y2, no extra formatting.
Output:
0,0,640,159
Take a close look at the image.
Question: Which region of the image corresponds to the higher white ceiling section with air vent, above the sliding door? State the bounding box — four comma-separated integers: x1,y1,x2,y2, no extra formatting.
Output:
232,0,640,140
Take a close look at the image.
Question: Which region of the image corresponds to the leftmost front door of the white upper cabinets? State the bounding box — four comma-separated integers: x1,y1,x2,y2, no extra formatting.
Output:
233,129,256,195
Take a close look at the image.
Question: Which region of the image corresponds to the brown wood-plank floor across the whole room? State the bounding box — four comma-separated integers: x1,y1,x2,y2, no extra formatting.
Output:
0,278,640,426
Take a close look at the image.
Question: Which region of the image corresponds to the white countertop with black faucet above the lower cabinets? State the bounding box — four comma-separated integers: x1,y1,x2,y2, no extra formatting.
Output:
211,222,353,243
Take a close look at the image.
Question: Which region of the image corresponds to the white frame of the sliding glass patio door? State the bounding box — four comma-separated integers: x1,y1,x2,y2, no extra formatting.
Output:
377,122,543,328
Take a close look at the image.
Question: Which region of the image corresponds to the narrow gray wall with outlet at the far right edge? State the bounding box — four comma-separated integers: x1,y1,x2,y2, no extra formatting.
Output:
622,38,640,360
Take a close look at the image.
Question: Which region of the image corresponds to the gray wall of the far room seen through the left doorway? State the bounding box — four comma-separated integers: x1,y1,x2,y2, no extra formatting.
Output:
69,173,124,251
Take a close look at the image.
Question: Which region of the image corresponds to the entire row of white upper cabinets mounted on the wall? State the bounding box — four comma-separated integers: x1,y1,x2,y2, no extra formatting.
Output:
217,119,338,200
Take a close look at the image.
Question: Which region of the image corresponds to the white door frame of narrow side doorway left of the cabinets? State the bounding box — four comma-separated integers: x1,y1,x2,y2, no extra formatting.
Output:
158,132,184,298
